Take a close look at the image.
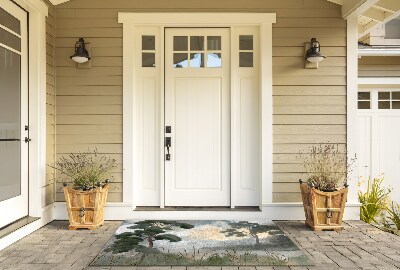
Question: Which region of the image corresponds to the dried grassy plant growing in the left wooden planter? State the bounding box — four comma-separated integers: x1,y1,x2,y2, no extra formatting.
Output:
49,149,116,190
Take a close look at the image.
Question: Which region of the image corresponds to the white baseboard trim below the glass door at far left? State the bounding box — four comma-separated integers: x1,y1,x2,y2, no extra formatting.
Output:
0,203,54,250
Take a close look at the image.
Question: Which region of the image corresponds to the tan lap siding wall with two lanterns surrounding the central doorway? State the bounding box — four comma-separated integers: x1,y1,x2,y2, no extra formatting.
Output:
55,0,346,202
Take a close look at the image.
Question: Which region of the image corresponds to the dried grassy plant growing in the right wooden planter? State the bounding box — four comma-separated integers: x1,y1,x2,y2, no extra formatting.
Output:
299,144,355,191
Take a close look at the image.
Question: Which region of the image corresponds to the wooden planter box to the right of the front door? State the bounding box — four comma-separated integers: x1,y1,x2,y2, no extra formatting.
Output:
300,183,348,231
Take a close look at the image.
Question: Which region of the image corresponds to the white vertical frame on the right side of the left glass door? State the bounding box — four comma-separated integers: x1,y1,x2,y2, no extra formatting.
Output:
14,0,48,217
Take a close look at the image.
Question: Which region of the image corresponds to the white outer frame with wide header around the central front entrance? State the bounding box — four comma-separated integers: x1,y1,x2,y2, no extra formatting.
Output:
118,12,276,209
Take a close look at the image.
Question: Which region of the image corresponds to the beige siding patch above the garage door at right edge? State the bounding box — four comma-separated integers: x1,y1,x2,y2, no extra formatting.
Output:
358,56,400,77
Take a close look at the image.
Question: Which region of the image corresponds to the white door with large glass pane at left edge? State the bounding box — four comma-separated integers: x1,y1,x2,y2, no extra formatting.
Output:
0,0,28,228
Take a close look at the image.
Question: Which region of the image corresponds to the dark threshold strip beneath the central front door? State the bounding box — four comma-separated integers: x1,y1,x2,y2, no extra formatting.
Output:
135,206,261,212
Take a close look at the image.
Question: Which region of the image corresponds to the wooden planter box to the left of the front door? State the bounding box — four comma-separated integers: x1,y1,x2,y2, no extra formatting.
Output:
64,184,109,230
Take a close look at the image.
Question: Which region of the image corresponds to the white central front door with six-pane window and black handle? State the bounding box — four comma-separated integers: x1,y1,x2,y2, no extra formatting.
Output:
165,28,231,206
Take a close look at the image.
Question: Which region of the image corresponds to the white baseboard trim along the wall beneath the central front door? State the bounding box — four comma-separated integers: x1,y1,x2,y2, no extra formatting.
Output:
54,202,360,220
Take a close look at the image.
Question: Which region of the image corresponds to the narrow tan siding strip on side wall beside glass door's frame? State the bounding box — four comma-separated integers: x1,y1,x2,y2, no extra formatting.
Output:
42,2,56,206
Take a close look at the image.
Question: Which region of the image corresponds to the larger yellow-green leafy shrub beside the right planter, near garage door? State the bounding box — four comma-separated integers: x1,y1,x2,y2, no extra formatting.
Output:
358,177,392,224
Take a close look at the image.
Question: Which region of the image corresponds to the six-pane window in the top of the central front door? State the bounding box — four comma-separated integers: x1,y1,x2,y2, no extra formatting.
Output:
173,36,222,68
